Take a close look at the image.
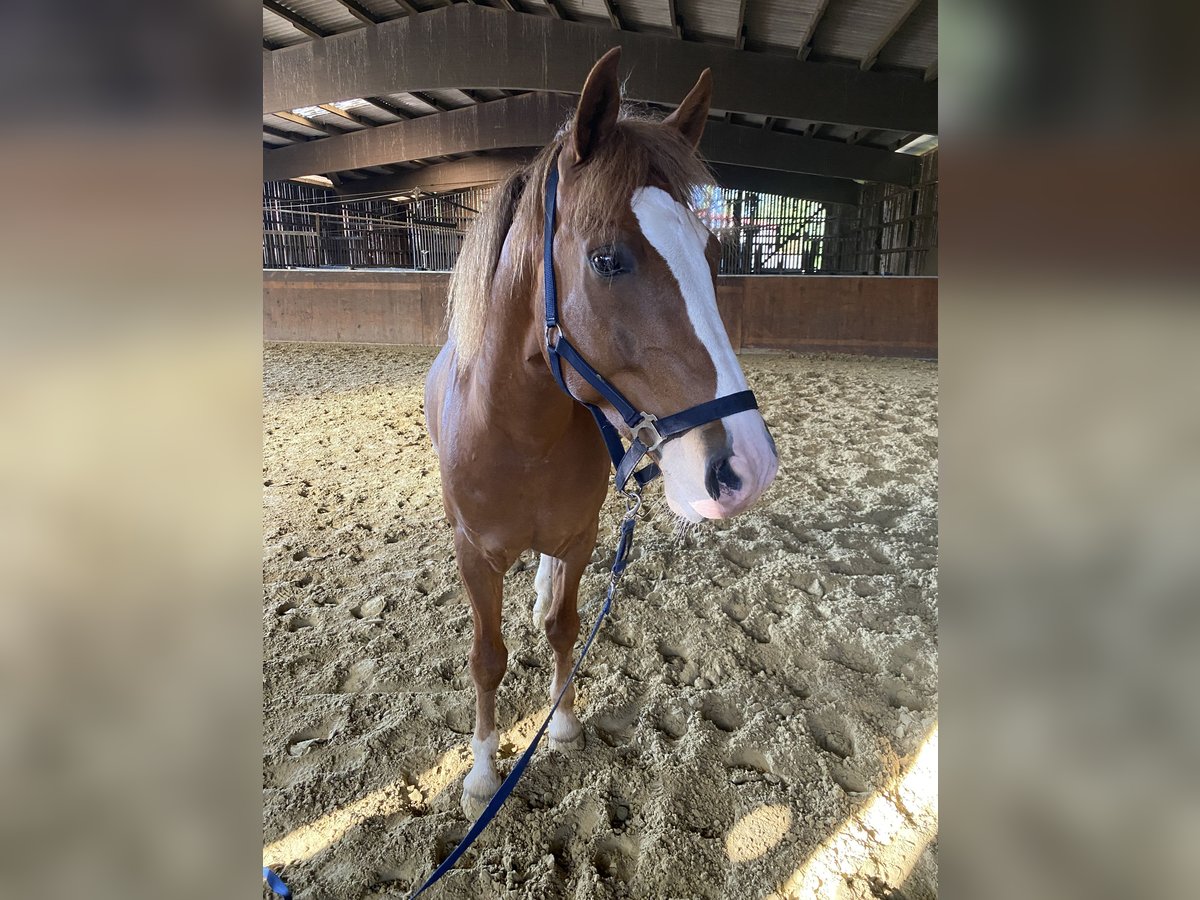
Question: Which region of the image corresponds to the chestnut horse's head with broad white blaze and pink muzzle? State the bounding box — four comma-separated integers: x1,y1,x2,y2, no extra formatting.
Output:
542,48,779,522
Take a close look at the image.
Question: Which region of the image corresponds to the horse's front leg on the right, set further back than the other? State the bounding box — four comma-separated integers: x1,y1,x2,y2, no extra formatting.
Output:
542,540,595,750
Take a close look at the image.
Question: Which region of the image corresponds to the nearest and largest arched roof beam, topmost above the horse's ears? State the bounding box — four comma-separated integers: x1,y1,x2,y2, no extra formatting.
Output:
263,4,937,134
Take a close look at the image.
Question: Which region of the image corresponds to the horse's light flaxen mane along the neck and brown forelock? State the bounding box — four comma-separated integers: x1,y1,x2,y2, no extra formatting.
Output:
446,107,713,359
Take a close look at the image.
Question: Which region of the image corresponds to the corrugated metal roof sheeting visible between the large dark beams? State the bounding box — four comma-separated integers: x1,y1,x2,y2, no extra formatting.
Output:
263,0,937,188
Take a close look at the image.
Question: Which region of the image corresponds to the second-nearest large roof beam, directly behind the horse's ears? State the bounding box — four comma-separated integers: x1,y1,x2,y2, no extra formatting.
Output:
263,94,920,185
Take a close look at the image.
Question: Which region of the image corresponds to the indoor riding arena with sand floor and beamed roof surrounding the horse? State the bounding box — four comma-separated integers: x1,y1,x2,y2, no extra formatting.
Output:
263,0,938,900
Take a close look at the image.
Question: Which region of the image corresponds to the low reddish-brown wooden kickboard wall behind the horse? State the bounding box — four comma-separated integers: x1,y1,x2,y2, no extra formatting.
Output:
263,269,937,358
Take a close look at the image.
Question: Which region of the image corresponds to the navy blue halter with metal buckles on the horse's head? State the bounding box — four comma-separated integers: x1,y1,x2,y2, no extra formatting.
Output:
542,156,758,493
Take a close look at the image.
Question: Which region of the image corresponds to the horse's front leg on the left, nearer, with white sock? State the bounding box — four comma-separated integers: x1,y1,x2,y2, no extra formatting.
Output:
455,533,509,818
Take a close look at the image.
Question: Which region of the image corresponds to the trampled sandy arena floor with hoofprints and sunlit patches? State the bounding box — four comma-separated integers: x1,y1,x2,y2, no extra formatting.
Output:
263,344,937,900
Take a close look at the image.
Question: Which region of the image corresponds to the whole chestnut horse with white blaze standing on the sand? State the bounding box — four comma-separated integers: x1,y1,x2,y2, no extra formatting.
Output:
425,49,778,816
